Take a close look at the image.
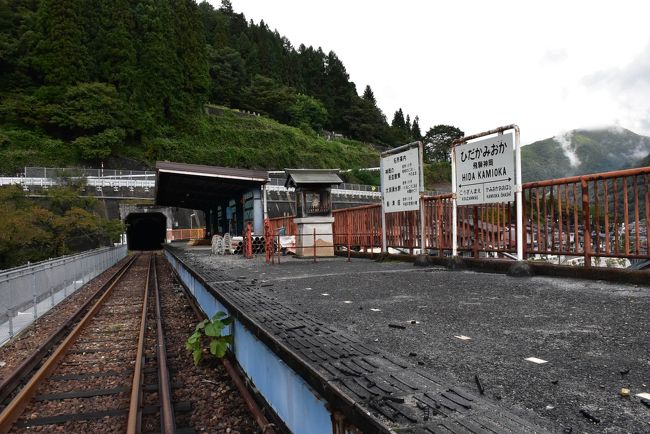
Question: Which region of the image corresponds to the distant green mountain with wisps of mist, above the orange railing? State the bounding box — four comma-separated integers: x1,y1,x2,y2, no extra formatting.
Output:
521,127,650,182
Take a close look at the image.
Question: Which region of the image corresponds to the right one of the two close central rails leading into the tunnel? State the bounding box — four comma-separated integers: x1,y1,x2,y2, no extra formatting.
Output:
152,255,176,434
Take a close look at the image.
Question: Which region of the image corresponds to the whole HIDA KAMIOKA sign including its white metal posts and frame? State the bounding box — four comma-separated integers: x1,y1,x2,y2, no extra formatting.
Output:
451,124,524,261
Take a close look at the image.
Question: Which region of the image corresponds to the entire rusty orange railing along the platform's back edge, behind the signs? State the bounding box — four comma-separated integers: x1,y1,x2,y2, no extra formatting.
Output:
270,167,650,266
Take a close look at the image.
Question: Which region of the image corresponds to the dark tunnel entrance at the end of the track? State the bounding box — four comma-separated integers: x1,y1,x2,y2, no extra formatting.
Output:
125,212,167,250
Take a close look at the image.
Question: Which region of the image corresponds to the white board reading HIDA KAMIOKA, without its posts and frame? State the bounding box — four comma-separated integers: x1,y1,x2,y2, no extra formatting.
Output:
454,133,515,206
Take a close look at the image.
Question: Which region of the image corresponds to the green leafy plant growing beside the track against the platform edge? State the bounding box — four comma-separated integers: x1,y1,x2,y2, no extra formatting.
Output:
185,312,233,366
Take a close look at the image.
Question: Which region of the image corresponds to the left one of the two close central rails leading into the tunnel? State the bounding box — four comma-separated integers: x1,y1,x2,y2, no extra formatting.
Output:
126,255,153,434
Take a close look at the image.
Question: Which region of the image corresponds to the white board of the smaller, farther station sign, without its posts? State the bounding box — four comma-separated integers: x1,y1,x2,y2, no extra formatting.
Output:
381,148,420,213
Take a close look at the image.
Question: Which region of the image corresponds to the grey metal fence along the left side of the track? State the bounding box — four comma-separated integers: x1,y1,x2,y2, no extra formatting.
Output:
0,244,127,343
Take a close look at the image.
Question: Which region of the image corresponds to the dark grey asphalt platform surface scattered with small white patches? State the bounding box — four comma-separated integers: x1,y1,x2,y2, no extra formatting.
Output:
190,249,650,433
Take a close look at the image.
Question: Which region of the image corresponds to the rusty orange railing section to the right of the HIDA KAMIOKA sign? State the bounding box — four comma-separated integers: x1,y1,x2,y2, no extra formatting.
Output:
524,167,650,265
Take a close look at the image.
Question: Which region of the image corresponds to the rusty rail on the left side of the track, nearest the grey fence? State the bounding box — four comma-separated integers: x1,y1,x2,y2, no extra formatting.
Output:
0,254,142,434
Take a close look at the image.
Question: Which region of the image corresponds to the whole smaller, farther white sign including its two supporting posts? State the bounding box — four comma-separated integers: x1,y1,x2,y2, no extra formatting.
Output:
380,142,424,252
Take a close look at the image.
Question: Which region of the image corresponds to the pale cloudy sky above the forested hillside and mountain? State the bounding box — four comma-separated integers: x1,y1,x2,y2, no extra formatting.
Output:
210,0,650,144
